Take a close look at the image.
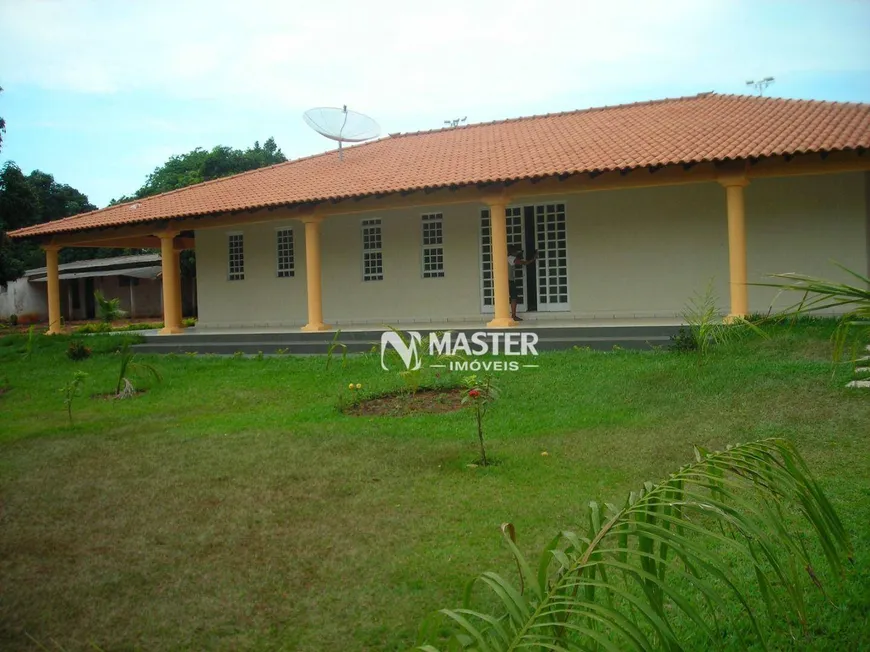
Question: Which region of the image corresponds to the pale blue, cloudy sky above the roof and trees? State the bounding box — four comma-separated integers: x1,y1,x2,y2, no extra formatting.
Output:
0,0,870,207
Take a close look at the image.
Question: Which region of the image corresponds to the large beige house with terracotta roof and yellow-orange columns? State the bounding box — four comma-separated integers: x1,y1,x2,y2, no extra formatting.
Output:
10,93,870,333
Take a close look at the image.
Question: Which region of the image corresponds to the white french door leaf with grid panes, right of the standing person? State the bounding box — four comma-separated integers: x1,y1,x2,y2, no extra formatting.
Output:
535,204,571,312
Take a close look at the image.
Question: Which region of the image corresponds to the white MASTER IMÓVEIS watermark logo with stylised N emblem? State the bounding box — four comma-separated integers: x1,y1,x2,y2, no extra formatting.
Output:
381,331,538,371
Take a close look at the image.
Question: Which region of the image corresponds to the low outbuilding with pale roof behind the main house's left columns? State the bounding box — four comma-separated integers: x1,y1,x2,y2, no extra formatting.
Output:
0,253,196,321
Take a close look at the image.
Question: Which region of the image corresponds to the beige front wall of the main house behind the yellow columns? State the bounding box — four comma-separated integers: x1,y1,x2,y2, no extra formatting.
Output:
196,173,868,327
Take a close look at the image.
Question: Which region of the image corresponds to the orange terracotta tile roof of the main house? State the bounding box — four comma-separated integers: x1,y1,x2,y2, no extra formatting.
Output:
10,93,870,237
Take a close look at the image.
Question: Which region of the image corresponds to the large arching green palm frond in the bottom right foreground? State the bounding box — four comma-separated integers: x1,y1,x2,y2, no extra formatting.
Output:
418,439,851,652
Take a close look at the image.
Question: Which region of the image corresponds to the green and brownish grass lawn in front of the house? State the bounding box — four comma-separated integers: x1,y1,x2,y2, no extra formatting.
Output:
0,322,870,651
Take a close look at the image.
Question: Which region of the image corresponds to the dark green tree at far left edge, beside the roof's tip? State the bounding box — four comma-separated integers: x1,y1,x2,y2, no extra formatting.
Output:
0,161,42,286
